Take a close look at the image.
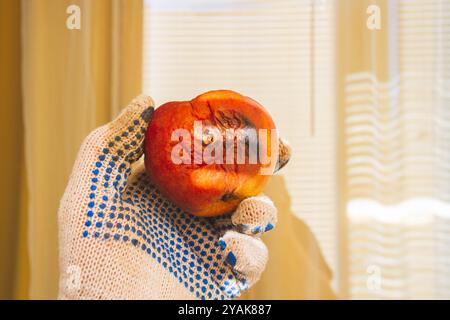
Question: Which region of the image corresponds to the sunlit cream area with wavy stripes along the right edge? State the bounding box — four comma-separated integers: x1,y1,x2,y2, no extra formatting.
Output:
345,0,450,299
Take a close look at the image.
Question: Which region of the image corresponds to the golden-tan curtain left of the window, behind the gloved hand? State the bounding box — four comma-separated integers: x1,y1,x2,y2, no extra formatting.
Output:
21,0,142,299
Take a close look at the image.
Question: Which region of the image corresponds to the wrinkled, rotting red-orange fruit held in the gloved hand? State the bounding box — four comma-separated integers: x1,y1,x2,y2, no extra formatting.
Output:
145,90,291,216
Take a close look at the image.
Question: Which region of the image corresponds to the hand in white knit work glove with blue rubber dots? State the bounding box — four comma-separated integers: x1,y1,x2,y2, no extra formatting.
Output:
58,96,276,299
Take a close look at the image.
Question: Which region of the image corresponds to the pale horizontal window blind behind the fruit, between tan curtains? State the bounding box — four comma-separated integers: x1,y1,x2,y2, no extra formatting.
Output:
143,0,337,298
